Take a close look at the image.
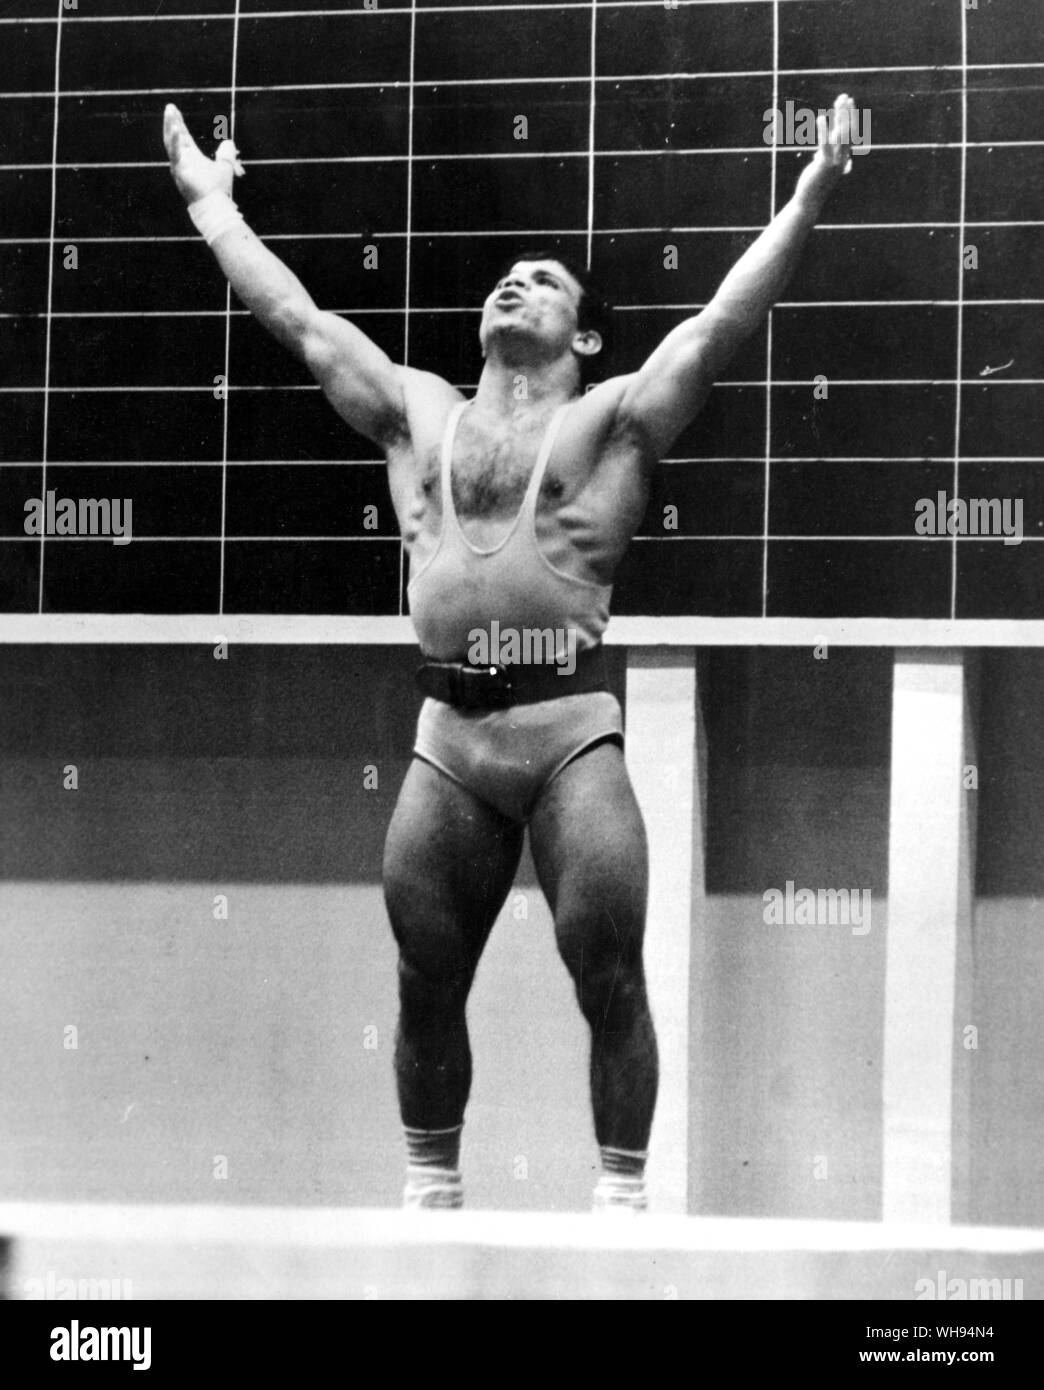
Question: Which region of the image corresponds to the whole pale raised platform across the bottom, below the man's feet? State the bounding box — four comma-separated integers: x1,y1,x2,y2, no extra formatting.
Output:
0,1204,1044,1315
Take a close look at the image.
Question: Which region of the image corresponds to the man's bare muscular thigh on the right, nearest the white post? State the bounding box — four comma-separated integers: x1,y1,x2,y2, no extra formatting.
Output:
530,742,648,970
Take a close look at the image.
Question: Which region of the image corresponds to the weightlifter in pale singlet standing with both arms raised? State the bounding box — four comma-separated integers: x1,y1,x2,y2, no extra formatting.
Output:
164,96,852,1211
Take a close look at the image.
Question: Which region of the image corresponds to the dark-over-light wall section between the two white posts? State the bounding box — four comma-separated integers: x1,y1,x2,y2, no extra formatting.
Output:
690,648,891,1220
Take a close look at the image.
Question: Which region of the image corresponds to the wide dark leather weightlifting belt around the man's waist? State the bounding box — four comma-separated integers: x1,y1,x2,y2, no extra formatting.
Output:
417,645,609,709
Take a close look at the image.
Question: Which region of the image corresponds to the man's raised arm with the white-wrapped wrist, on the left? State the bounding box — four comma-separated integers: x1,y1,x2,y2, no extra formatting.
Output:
163,106,406,448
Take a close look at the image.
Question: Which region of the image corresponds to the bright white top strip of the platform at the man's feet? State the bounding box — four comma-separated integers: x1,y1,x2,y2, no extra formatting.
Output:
0,1202,1044,1254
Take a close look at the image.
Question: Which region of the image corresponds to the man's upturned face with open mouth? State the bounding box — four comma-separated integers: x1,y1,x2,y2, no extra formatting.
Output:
478,260,582,357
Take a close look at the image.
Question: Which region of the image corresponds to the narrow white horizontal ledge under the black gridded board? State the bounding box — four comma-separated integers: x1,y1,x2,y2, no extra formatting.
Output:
0,613,1044,648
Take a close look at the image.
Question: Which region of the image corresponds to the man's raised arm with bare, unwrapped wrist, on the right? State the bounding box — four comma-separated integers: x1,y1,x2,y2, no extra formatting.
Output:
616,96,854,460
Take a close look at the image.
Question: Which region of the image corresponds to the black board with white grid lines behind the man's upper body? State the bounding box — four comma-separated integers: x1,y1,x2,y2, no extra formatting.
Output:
0,0,1044,617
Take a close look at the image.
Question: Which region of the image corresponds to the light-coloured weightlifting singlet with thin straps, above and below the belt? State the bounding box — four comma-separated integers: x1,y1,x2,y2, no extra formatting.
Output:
409,400,623,820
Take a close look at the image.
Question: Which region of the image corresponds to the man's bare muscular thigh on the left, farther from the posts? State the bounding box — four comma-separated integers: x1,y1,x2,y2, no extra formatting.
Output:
384,758,523,984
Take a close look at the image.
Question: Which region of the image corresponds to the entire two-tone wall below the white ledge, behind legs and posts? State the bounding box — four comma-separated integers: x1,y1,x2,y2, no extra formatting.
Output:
0,646,1044,1225
